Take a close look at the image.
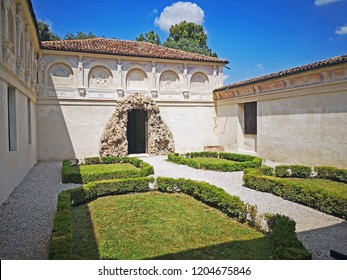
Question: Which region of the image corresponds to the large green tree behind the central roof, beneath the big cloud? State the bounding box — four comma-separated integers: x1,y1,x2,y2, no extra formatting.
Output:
164,21,217,57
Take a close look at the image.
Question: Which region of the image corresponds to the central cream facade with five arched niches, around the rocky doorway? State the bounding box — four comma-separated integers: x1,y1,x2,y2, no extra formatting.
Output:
37,50,224,160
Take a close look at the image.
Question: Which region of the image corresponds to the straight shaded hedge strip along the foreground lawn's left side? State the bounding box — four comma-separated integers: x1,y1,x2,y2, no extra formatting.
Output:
48,191,72,260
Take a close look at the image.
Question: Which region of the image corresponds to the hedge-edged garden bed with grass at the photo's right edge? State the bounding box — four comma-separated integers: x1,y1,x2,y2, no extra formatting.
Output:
243,165,347,219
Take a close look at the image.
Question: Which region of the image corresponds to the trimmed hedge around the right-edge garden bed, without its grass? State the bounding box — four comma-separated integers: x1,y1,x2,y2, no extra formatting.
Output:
243,166,347,219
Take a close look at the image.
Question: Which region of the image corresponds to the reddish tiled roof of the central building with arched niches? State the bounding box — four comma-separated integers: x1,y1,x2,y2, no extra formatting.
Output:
41,38,228,63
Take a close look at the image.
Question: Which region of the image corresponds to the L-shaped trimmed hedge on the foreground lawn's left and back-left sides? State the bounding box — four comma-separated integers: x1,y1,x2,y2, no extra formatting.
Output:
49,178,155,260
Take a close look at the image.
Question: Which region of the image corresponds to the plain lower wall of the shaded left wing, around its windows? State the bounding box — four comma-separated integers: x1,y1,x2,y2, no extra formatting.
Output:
0,79,37,204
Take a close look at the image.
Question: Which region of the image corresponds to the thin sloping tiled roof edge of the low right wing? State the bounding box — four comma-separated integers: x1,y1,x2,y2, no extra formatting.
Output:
213,55,347,92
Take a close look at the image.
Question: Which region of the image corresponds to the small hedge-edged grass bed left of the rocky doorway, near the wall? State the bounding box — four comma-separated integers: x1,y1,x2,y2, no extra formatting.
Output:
62,157,154,184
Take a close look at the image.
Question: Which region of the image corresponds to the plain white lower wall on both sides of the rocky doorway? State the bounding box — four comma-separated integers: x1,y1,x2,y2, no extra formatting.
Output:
37,104,217,160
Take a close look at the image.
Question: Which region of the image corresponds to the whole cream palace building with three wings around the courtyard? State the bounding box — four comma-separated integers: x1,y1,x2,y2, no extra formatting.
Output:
0,0,347,206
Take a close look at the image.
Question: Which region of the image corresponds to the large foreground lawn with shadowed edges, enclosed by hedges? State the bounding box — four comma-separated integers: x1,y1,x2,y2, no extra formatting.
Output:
72,192,273,259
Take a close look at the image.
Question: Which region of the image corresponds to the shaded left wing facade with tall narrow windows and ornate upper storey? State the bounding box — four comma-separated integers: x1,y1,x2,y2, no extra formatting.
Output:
0,0,39,204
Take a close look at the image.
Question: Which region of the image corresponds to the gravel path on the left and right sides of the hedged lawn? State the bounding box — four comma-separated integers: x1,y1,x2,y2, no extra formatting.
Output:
0,156,347,259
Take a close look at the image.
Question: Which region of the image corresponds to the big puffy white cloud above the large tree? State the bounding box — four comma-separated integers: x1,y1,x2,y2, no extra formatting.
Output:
154,2,205,32
